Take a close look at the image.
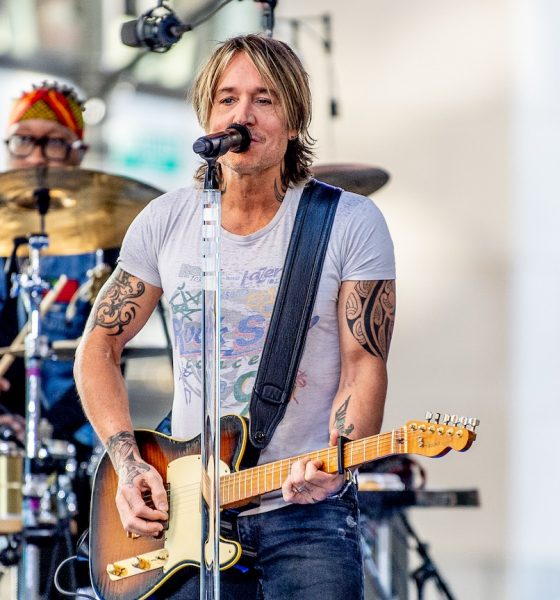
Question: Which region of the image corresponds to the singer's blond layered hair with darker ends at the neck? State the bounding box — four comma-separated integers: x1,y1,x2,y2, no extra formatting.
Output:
191,34,315,187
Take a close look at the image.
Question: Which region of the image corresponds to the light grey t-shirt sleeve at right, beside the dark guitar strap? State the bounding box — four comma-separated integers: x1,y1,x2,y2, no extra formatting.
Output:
334,193,395,281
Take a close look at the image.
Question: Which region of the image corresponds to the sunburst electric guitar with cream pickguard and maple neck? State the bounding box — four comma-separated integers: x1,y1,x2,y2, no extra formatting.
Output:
90,413,478,600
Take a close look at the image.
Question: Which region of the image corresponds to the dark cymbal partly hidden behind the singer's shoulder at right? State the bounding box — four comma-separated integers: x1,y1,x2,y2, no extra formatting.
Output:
311,163,390,196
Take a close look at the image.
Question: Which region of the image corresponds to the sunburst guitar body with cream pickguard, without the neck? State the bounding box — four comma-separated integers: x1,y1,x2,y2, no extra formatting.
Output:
90,415,248,600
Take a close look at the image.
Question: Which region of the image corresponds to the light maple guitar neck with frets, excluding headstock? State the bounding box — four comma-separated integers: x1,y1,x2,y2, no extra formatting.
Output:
220,427,407,508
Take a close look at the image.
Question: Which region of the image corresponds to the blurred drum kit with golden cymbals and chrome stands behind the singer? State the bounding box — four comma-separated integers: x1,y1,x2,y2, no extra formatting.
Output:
0,159,389,598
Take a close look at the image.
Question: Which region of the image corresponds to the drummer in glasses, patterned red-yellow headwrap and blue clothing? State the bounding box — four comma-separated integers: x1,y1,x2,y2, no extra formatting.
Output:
0,82,117,450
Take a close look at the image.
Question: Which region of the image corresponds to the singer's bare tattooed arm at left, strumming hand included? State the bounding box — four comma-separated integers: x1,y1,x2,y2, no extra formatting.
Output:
74,268,167,535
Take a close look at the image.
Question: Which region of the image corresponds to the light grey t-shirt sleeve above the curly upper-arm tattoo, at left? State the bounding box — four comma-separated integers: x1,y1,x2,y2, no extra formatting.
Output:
118,202,161,287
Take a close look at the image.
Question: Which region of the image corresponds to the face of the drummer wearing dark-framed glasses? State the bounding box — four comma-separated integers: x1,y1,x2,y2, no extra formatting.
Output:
6,119,84,169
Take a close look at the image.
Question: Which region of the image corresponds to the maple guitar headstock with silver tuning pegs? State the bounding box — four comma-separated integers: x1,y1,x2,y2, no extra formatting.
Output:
406,412,480,457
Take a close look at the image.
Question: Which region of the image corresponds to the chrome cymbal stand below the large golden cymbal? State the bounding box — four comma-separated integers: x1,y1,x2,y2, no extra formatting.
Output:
16,233,52,600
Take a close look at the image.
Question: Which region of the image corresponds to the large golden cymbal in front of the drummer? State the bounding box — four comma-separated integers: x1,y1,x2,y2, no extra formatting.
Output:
0,166,162,256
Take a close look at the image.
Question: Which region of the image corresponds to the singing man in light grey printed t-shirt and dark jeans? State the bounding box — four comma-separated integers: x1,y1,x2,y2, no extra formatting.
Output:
75,35,395,600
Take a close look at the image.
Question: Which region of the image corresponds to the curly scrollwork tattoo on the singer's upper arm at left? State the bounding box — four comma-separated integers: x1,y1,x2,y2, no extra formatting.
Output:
93,269,146,335
